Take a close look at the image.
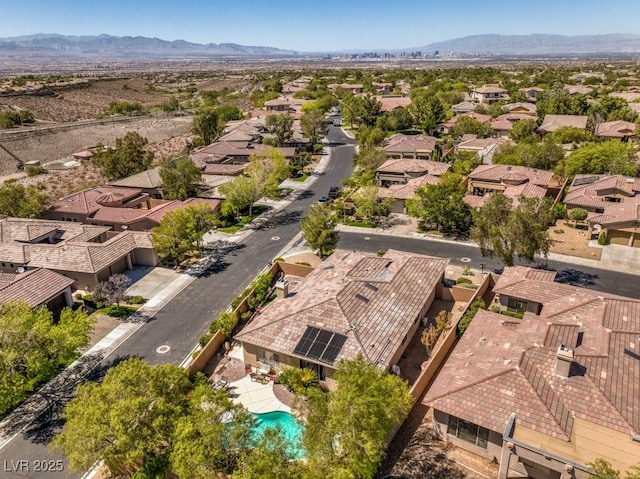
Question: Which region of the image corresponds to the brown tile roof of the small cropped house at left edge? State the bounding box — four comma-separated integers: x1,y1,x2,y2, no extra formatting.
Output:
0,269,74,306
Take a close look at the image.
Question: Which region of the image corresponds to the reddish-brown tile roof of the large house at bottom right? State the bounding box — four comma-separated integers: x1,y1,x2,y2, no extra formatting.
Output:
424,267,640,441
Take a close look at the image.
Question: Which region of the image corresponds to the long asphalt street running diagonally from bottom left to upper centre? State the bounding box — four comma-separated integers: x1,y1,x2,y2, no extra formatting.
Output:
0,126,355,479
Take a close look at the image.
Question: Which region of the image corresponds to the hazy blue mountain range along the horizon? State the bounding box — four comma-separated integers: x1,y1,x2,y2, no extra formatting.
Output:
0,34,640,59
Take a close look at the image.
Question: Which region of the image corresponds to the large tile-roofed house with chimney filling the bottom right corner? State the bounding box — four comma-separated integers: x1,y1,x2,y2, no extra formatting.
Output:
423,266,640,479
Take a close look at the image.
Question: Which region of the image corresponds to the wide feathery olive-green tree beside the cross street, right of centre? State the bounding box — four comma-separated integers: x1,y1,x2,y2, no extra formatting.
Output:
471,192,553,266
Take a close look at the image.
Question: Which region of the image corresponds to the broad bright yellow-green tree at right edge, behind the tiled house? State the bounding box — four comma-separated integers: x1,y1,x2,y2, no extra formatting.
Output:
556,140,638,176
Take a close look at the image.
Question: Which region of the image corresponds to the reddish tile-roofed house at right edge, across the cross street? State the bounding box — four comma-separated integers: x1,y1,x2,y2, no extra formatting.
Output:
564,175,640,248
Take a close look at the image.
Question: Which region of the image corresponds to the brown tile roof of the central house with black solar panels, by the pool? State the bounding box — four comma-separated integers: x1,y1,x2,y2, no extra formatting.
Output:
236,250,448,367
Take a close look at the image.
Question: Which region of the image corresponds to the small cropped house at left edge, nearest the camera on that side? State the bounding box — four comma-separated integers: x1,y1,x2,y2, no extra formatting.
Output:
0,268,74,311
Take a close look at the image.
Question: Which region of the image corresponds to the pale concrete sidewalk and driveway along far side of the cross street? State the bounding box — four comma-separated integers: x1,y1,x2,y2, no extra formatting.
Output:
336,224,640,275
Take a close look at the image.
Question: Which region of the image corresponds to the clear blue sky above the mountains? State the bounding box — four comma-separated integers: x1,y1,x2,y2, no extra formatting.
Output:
0,0,640,51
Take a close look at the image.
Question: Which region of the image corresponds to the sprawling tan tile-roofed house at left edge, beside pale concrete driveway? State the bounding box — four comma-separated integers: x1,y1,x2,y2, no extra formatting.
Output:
0,218,158,289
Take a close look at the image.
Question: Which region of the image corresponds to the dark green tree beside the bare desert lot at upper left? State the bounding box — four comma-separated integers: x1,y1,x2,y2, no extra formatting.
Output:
91,131,153,180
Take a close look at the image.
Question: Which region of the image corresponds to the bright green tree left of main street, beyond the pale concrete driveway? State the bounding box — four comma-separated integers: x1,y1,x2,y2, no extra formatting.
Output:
151,203,217,265
